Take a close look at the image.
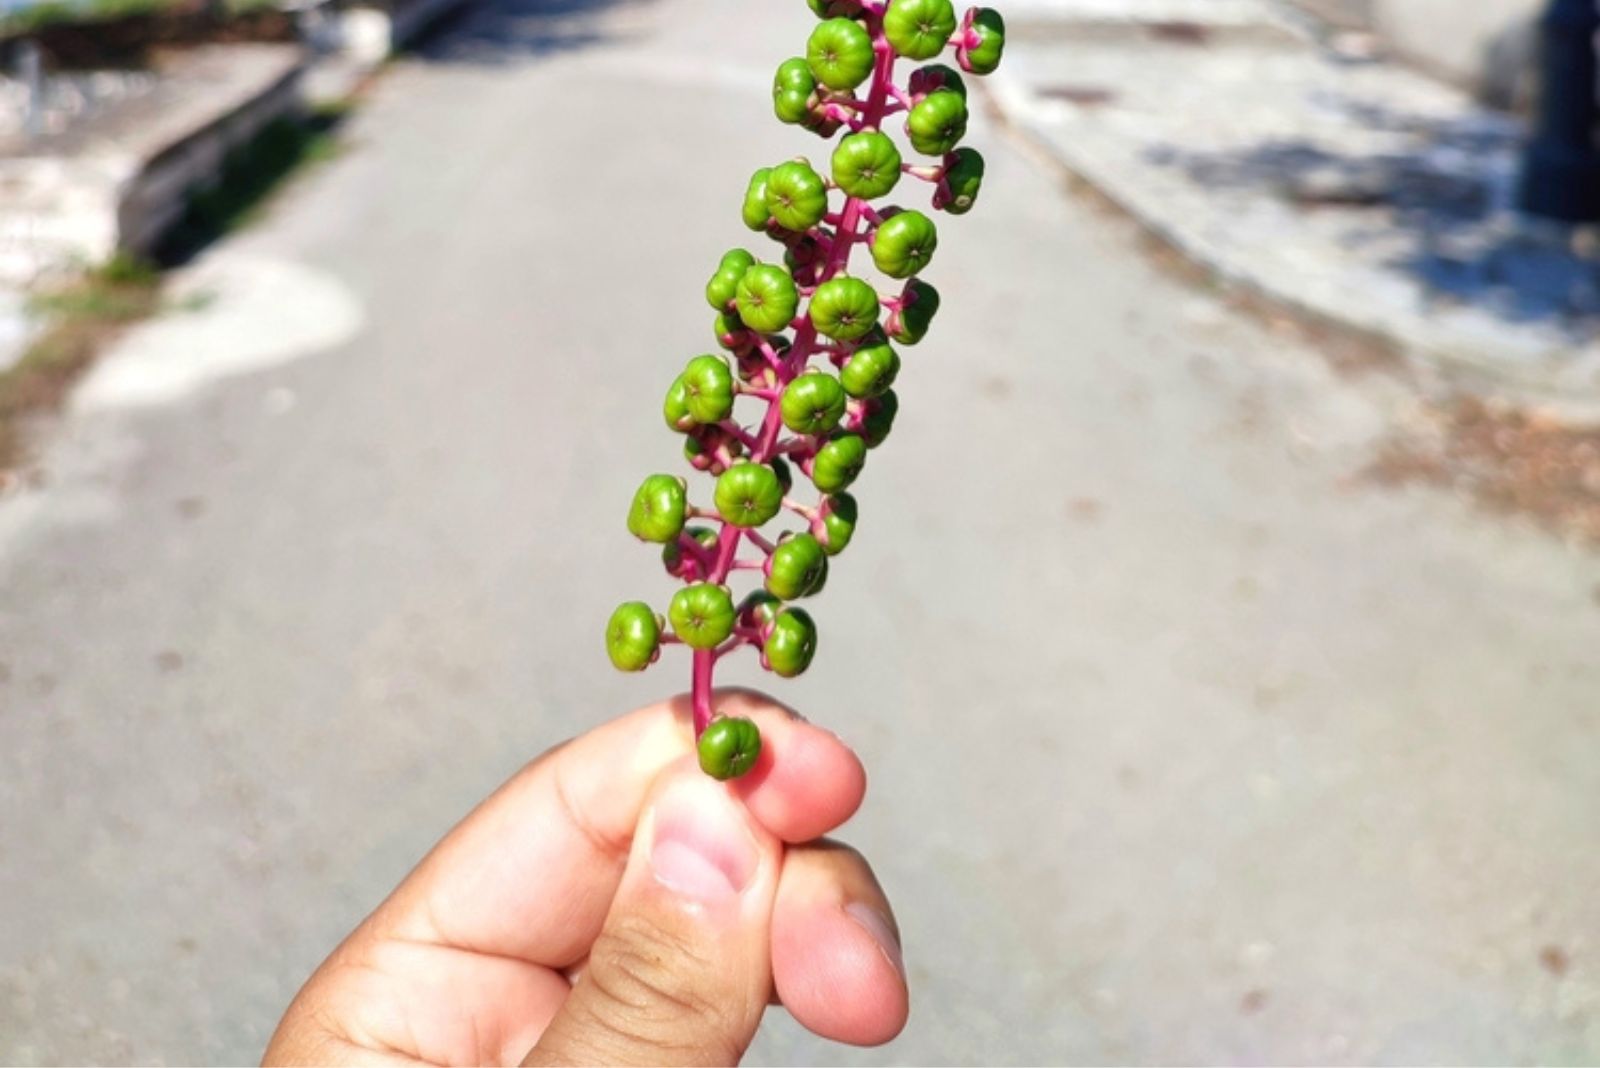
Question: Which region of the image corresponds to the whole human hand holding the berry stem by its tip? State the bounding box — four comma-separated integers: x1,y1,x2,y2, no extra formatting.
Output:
264,691,907,1065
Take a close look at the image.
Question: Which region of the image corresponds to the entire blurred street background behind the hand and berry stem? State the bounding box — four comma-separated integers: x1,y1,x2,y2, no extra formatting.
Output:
0,0,1600,1063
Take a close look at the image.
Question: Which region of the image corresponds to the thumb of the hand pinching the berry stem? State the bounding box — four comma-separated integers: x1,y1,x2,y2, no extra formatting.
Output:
523,761,781,1065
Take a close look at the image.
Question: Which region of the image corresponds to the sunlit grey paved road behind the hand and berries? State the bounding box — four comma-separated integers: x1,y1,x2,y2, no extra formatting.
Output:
0,0,1600,1063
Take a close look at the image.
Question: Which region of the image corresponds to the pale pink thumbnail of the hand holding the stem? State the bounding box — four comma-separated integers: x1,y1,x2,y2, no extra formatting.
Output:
650,785,760,902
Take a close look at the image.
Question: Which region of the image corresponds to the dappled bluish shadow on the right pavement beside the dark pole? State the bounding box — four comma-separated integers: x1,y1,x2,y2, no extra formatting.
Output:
1152,101,1600,333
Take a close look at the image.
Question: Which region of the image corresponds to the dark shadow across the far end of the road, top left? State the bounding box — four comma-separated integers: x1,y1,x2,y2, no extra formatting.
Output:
413,0,653,66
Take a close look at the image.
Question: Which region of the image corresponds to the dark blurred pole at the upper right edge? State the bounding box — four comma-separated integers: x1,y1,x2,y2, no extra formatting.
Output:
1517,0,1600,222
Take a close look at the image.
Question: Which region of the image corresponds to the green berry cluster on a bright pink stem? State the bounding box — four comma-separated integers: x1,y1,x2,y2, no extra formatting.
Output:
606,0,1005,779
